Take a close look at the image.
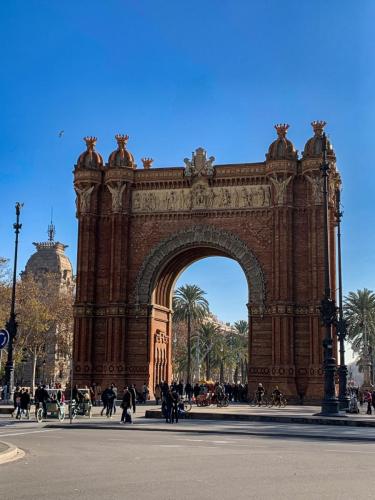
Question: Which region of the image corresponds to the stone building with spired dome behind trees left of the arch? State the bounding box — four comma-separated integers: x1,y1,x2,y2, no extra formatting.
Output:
18,223,74,386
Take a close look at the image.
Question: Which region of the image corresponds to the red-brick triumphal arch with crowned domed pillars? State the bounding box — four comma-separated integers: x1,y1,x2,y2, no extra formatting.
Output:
74,121,340,401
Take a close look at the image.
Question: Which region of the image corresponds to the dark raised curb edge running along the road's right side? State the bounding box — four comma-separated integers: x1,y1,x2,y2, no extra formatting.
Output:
145,410,375,428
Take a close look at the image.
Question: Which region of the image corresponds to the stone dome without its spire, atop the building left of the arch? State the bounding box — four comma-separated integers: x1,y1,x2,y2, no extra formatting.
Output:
25,241,73,286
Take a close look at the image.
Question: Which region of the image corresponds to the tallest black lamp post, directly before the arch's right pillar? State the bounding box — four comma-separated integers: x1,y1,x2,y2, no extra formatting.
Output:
320,133,339,415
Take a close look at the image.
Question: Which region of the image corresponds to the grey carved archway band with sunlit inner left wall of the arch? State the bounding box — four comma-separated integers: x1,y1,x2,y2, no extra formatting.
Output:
136,226,265,388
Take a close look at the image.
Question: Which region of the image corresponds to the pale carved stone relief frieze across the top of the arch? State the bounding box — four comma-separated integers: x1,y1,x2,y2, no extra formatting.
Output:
132,183,271,213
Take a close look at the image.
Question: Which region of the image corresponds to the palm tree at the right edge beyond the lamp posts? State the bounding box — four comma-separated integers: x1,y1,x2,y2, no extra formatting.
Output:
344,288,375,384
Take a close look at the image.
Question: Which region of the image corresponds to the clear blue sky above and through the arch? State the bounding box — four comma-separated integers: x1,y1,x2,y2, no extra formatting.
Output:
0,0,375,328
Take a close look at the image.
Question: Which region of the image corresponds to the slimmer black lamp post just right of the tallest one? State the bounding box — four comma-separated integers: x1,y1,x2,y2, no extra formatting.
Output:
336,188,350,410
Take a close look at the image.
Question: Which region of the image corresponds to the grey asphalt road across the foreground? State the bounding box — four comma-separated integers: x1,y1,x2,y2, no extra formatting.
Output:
0,418,375,500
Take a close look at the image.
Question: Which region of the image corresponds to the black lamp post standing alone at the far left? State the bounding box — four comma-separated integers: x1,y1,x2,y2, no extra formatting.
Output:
5,202,23,398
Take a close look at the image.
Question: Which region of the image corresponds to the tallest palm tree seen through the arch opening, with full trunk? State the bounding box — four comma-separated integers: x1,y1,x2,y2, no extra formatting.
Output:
173,285,209,383
